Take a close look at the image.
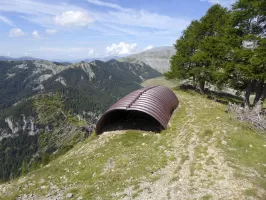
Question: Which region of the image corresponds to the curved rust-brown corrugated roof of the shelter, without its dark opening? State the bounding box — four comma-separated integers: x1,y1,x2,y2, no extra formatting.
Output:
96,86,179,134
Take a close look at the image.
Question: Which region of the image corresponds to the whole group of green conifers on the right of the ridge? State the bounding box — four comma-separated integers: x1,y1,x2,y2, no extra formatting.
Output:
165,0,266,106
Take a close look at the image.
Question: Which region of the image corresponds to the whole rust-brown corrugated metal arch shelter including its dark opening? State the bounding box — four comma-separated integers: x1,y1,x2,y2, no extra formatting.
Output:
96,86,179,134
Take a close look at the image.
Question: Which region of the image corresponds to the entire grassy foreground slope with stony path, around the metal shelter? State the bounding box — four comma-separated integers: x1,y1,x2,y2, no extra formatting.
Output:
0,80,266,200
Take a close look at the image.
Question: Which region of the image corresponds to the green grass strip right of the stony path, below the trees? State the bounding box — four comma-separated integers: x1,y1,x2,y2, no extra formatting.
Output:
172,90,266,194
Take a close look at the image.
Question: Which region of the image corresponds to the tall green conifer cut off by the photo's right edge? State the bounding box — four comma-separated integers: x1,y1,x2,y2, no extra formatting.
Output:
227,0,266,107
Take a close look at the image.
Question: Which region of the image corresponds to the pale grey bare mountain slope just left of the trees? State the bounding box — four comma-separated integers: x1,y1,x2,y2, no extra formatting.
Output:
118,46,176,73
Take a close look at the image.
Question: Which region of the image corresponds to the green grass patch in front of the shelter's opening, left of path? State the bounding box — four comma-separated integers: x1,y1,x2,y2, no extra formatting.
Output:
0,131,167,199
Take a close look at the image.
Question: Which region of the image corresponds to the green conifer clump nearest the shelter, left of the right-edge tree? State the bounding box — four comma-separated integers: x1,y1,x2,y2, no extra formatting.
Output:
165,5,229,89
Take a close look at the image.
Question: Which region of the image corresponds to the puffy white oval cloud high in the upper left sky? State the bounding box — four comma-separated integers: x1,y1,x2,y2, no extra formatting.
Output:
54,11,94,26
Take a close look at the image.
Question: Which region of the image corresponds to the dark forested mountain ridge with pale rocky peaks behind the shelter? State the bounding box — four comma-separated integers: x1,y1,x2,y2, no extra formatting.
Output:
0,60,161,133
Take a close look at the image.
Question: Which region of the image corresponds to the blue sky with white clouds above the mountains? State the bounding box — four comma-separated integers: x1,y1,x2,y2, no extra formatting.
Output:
0,0,237,60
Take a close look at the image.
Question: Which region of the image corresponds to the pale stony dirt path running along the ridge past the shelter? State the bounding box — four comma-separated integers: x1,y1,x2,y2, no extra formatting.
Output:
121,92,265,200
